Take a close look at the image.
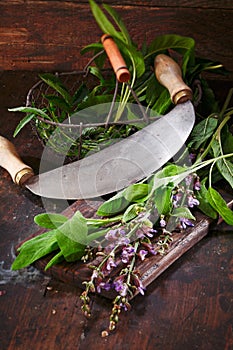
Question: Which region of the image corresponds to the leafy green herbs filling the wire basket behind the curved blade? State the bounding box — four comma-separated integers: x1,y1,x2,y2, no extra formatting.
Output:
10,0,223,158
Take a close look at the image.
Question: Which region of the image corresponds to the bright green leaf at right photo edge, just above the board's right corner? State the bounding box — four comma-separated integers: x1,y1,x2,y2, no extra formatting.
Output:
206,187,233,225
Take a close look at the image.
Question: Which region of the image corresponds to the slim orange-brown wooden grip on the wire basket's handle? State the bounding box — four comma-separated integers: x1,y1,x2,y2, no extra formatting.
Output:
101,34,130,83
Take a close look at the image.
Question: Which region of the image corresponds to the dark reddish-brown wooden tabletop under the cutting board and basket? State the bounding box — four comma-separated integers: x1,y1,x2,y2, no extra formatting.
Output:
0,72,233,350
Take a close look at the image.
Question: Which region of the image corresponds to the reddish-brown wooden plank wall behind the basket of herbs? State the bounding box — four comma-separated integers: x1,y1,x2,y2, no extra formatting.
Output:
0,0,233,80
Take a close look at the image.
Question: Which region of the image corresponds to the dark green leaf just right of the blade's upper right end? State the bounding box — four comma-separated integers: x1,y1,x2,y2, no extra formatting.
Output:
189,118,218,149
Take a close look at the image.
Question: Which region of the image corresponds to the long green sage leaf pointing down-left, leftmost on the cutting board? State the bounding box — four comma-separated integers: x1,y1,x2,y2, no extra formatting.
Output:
11,230,58,270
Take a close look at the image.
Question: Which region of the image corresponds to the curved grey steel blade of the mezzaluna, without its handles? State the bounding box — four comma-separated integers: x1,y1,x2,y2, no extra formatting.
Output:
26,101,195,199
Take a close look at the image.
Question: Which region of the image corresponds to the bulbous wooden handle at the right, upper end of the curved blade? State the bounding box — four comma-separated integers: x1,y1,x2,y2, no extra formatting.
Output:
155,54,193,105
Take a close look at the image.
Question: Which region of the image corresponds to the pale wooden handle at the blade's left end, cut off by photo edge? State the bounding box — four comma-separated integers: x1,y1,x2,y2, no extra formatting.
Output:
0,136,34,185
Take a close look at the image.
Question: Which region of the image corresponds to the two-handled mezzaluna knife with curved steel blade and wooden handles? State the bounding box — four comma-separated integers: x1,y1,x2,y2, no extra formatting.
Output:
0,53,195,199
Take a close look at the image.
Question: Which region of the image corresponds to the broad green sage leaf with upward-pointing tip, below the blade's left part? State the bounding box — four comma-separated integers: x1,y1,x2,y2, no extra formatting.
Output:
56,211,88,262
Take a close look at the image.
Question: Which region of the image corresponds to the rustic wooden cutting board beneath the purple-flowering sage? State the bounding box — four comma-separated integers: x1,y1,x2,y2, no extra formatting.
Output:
16,200,212,299
